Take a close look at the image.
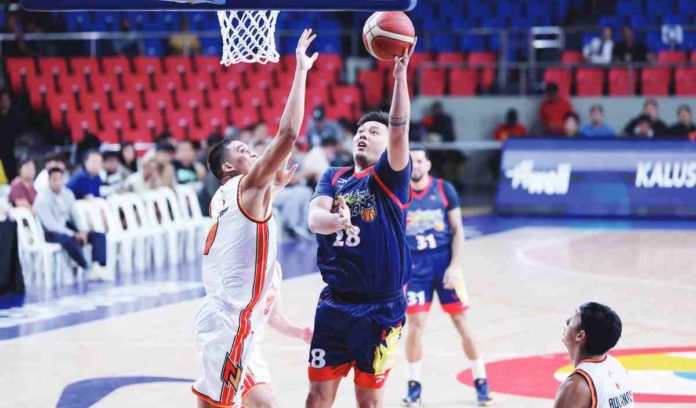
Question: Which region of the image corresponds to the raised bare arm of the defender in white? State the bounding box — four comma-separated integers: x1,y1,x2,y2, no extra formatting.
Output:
242,29,318,199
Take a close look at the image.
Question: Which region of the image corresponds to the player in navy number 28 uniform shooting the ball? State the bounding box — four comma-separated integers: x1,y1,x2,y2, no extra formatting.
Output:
306,43,415,408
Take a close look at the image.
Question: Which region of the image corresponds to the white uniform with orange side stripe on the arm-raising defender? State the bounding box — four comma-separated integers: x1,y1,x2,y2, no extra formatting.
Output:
193,176,277,407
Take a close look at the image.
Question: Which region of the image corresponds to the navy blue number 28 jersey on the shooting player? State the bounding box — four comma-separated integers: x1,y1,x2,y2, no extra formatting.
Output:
314,152,411,300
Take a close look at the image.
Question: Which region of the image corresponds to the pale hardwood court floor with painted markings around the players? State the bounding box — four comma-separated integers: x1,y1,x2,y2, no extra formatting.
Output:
0,228,696,408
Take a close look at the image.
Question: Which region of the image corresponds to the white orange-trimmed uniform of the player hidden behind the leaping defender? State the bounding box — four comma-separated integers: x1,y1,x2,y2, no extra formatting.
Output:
235,262,283,406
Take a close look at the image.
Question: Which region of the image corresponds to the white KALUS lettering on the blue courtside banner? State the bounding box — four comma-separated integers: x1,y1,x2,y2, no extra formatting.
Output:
636,161,696,188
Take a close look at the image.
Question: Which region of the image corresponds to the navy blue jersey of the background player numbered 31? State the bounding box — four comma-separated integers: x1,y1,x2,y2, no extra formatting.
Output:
406,176,459,258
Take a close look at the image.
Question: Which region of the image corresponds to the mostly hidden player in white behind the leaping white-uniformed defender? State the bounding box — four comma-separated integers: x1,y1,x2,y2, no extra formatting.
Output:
235,262,312,408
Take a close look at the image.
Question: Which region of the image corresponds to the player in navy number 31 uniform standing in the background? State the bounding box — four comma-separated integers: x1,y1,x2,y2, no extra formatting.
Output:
403,150,491,406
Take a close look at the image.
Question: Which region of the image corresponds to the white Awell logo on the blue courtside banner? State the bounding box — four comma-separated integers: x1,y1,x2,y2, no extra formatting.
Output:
505,160,571,195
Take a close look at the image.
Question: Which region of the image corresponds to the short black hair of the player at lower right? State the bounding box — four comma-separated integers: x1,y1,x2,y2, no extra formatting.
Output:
579,302,622,356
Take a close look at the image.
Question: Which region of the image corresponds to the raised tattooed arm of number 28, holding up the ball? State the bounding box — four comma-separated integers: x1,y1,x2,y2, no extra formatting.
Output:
387,39,418,171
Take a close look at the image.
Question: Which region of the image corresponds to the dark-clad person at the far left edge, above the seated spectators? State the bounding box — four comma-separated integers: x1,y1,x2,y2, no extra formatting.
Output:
0,88,26,180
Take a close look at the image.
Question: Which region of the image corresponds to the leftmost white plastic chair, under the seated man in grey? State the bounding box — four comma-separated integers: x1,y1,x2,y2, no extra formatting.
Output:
10,208,64,288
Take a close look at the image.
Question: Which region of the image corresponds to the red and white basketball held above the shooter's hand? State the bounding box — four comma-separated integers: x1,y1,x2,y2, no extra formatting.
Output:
363,11,416,60
